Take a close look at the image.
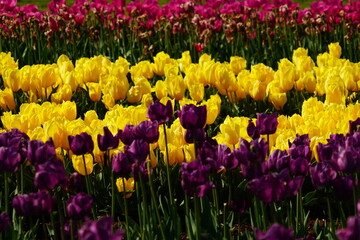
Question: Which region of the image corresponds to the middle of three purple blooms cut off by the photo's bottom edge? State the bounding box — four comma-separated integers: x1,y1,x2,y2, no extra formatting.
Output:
255,223,294,240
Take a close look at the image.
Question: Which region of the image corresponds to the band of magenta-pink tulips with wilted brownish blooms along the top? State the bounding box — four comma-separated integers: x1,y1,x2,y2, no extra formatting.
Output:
0,0,360,65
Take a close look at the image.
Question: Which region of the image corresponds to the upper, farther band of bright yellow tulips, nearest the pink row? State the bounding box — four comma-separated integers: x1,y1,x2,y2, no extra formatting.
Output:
0,43,360,113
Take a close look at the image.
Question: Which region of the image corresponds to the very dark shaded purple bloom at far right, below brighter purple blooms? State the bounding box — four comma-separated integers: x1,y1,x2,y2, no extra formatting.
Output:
333,176,354,201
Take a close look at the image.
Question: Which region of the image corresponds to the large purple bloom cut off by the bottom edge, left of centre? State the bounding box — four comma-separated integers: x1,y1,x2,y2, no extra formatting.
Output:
78,217,125,240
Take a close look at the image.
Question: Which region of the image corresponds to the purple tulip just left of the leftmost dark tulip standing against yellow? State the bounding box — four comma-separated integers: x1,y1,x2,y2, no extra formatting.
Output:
27,140,56,166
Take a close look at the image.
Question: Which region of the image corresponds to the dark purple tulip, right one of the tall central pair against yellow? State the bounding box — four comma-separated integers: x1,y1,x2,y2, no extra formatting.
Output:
178,104,207,130
